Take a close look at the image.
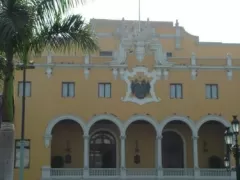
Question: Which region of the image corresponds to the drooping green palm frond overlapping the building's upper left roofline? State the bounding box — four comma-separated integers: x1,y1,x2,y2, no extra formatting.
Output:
31,15,98,53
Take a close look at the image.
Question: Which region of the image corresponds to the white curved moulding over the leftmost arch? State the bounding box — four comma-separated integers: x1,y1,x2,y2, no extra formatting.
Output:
44,115,86,147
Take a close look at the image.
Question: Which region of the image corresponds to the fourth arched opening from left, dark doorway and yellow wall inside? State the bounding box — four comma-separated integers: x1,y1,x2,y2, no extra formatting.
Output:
162,119,194,168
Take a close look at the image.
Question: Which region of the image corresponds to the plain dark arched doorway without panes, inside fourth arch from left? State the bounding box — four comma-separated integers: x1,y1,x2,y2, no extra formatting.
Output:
162,131,184,168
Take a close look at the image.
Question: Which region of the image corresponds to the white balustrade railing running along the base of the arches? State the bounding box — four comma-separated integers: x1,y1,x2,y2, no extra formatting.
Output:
42,167,235,180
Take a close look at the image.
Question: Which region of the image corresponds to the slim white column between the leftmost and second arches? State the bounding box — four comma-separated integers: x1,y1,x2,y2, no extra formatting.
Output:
83,135,89,177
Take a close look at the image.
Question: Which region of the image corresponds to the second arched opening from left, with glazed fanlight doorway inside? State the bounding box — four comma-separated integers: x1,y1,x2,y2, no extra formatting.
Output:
89,120,120,168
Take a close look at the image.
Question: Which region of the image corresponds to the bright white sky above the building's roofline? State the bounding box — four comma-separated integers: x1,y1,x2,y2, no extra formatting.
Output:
73,0,240,43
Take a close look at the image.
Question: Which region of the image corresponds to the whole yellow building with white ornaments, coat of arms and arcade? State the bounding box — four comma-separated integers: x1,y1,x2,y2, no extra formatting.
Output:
15,19,240,180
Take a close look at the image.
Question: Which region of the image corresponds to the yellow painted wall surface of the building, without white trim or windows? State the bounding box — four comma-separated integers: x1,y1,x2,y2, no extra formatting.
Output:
12,18,240,179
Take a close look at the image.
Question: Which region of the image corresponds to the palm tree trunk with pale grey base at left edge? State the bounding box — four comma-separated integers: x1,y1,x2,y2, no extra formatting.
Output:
0,46,15,180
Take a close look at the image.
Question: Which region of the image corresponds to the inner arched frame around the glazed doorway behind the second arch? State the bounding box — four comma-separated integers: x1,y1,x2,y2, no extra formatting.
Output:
88,128,120,168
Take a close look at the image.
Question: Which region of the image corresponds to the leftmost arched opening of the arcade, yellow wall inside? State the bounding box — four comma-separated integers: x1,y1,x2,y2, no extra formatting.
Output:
51,120,83,168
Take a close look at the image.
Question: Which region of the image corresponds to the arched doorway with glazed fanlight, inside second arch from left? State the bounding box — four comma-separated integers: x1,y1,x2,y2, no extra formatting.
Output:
89,131,117,168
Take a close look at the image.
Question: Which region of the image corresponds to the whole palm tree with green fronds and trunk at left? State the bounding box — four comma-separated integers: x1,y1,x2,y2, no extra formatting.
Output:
0,0,98,177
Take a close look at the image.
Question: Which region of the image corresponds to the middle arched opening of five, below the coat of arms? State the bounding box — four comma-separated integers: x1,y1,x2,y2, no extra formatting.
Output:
126,119,157,168
